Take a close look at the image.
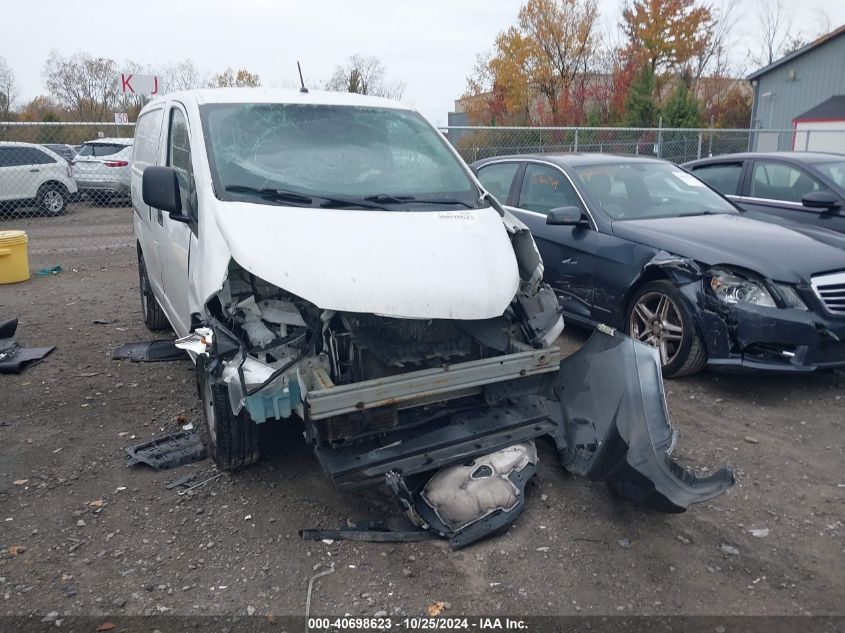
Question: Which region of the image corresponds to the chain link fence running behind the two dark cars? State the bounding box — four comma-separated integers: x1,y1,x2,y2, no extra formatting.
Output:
441,127,845,163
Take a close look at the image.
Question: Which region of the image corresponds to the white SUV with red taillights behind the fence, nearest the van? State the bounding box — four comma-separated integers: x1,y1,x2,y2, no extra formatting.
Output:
73,138,133,203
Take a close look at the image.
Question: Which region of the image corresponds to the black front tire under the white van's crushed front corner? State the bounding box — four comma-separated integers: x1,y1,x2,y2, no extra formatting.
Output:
197,357,261,470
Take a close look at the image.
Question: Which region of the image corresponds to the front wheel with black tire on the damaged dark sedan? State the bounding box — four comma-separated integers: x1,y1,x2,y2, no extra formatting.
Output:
625,280,707,378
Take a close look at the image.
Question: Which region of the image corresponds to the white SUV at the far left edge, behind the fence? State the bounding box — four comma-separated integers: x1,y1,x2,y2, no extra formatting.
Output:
0,141,77,215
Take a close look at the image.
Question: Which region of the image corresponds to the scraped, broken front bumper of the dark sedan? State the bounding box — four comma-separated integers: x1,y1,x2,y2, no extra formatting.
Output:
700,300,845,373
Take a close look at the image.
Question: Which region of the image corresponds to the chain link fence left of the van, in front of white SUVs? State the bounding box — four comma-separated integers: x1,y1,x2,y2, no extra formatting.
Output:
0,122,135,270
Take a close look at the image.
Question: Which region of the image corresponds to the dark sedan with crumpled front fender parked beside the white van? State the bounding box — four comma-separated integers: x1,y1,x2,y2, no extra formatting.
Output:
474,154,845,376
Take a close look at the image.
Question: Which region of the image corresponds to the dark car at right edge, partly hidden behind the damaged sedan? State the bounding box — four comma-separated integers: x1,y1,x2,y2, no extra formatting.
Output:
683,152,845,233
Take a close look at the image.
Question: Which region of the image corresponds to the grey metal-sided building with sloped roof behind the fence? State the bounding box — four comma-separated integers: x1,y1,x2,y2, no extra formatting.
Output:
748,25,845,151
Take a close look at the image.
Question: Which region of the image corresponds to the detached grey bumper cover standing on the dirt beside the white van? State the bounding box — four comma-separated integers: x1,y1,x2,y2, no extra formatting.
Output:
556,332,734,512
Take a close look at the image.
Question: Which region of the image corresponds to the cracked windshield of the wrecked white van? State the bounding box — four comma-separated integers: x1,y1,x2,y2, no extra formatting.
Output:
201,104,486,211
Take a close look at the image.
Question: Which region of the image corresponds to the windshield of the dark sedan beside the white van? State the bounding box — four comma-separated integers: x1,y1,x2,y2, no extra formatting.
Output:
575,162,737,220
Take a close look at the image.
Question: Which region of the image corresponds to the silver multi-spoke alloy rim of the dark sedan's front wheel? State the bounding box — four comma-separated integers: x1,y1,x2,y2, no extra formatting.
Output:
628,292,684,365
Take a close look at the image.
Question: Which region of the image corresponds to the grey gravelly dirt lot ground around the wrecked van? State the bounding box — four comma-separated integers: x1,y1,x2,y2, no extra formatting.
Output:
0,208,845,616
